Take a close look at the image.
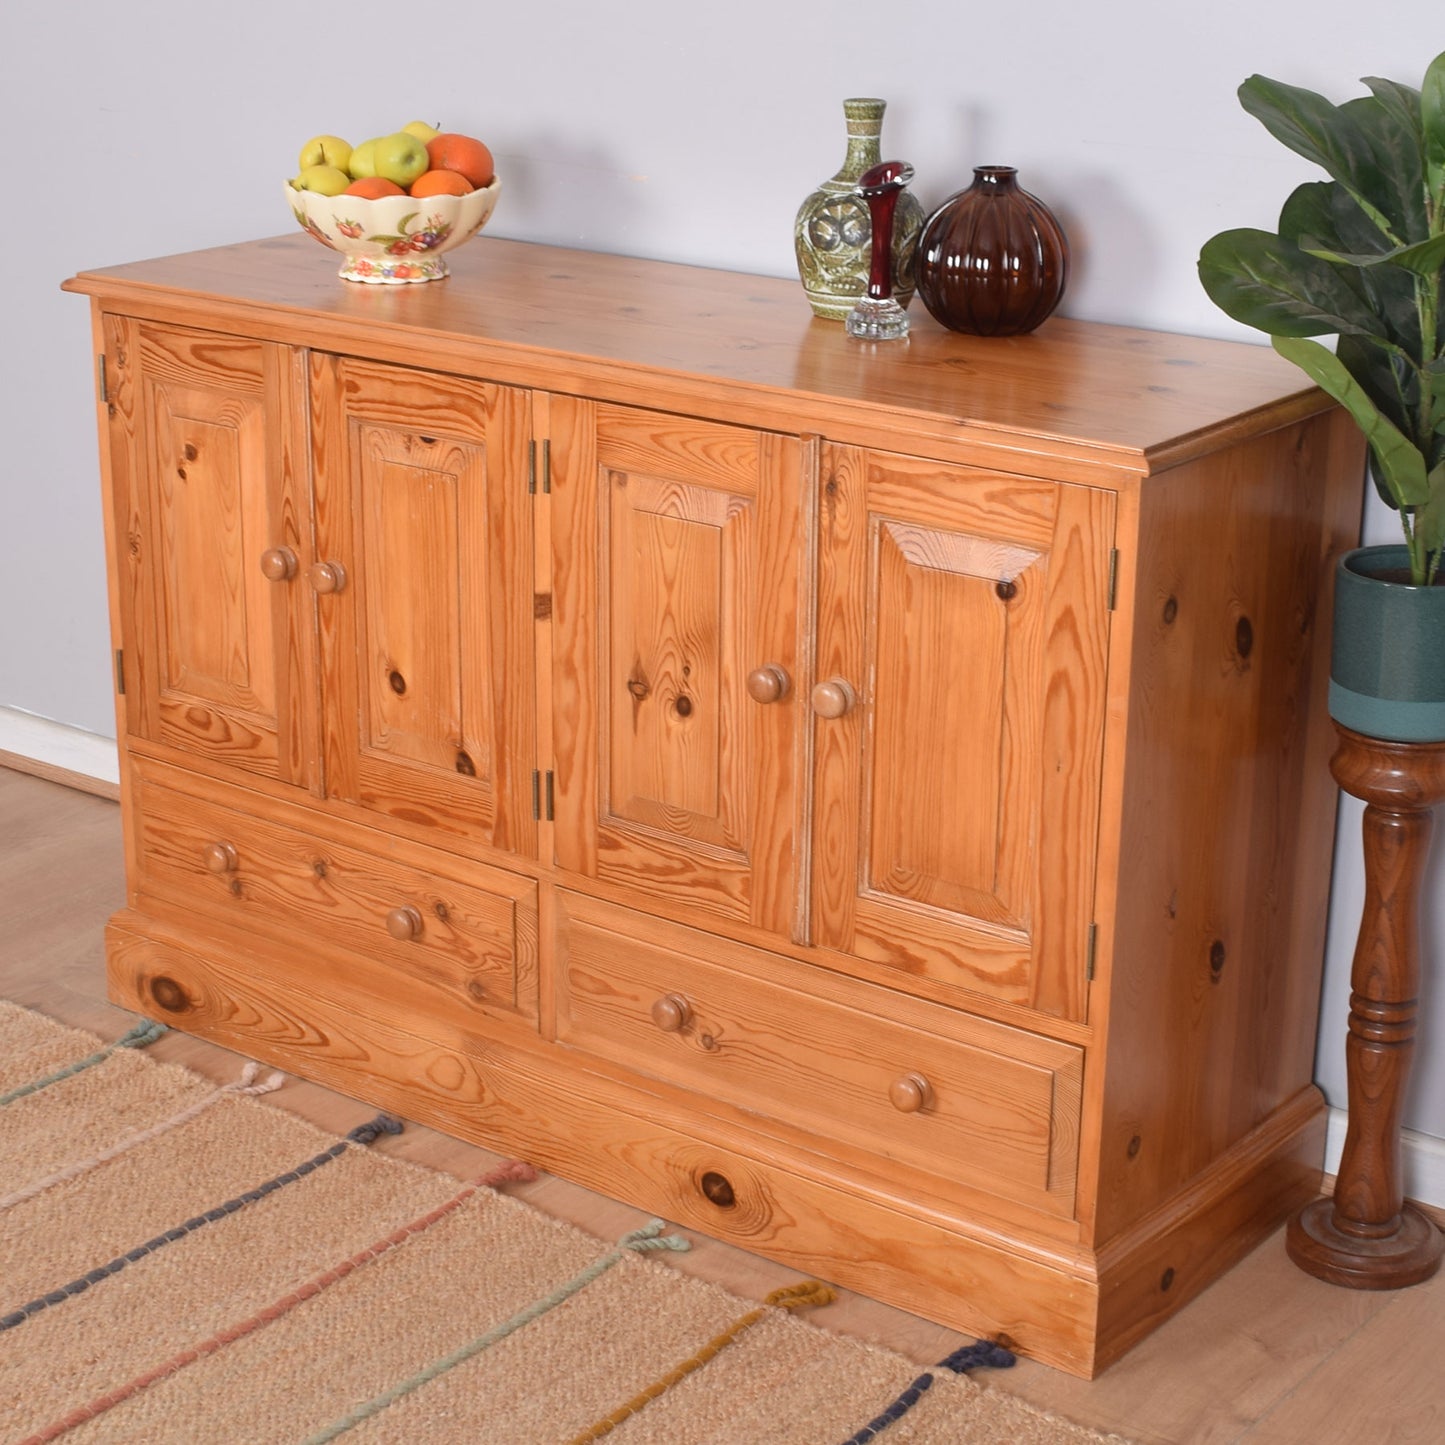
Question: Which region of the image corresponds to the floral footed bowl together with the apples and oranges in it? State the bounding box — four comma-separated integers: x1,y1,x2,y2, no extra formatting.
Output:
286,120,501,285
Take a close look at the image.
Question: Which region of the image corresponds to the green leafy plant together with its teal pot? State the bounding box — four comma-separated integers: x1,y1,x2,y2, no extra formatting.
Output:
1199,55,1445,743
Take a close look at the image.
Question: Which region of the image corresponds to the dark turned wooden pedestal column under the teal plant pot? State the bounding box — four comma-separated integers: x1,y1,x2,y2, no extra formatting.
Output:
1285,723,1445,1289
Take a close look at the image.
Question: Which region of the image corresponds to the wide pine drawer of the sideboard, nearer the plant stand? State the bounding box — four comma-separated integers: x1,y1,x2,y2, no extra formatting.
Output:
555,893,1084,1215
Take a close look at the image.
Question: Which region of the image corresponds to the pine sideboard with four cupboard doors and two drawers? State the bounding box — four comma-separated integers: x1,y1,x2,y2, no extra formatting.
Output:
66,234,1363,1376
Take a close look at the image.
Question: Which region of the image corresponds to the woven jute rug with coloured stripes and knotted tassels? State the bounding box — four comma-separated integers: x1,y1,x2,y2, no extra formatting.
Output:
0,1003,1117,1445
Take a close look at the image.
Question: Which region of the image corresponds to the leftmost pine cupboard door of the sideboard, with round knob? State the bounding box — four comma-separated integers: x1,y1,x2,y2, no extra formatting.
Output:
105,316,315,786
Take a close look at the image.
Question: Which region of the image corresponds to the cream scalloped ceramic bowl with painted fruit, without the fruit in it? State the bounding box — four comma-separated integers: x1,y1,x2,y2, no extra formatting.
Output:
286,178,501,286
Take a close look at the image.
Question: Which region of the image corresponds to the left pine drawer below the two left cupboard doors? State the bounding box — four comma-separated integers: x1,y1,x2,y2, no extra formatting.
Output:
136,780,538,1016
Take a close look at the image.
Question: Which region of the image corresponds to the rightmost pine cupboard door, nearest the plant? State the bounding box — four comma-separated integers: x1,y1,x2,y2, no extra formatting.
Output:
811,447,1114,1019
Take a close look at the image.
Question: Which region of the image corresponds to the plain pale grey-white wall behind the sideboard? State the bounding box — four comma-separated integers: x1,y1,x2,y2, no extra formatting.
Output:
0,0,1445,1136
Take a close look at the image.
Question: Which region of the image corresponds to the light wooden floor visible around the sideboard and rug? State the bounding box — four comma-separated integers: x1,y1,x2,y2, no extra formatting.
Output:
0,767,1445,1445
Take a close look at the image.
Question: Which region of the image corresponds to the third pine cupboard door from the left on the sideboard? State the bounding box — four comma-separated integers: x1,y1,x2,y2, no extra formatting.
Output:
551,397,806,935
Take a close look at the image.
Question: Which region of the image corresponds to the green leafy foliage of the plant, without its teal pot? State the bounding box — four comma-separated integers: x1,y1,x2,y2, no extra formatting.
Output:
1199,53,1445,587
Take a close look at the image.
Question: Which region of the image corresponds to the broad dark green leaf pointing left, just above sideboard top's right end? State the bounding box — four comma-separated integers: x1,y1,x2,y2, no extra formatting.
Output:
1199,230,1389,340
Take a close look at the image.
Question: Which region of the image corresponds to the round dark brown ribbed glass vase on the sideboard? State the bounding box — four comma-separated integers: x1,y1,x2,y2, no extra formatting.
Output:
916,166,1069,337
